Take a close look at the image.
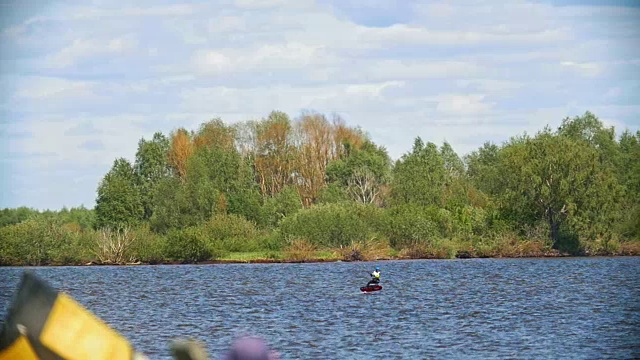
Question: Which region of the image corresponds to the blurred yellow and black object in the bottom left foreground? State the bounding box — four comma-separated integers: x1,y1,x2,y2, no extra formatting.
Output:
0,272,147,360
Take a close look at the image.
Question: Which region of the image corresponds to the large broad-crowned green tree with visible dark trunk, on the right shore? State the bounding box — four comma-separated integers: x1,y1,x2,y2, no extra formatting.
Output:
499,128,619,251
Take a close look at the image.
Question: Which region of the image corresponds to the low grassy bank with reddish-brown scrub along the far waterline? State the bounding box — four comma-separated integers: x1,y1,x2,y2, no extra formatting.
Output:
0,239,640,266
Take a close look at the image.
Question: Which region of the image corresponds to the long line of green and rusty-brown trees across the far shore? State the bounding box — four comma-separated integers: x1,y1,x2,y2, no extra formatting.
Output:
0,111,640,264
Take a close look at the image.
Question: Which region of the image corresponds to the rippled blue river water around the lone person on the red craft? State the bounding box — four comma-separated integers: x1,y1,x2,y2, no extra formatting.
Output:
0,257,640,359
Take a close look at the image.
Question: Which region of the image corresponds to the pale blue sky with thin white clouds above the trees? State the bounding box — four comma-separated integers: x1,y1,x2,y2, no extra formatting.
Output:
0,0,640,210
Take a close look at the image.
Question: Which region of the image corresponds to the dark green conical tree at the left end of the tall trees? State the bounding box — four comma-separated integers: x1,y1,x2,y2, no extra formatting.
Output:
95,158,144,229
